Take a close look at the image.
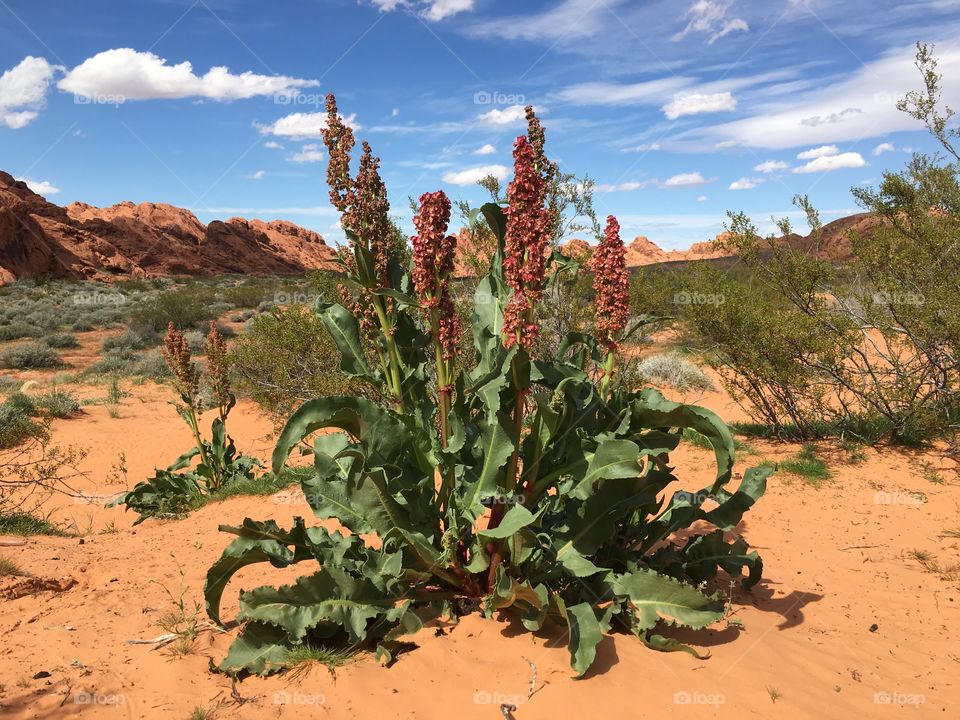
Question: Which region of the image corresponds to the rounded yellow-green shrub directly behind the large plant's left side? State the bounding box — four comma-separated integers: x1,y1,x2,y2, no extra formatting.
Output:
230,305,361,418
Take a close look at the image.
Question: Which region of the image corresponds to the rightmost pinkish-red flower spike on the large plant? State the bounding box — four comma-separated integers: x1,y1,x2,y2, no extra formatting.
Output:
593,215,630,352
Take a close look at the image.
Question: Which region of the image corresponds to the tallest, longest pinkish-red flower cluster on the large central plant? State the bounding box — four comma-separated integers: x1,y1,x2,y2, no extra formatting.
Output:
503,135,550,349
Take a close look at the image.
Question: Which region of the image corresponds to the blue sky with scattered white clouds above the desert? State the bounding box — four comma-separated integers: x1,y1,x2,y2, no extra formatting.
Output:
0,0,960,248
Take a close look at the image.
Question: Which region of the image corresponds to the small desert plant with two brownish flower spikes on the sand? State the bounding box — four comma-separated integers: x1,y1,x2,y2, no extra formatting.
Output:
108,322,260,524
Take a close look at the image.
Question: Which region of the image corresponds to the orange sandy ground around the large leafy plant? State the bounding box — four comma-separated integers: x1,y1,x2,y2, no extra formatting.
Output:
0,348,960,720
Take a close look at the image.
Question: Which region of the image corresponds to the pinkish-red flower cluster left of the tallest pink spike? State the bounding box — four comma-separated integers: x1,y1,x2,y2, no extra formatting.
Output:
412,191,460,360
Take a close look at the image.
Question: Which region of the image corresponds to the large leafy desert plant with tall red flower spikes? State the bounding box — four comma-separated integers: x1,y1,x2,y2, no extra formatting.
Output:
205,96,770,674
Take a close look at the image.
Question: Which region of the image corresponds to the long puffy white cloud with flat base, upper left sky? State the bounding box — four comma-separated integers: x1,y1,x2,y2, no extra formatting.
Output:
57,48,319,101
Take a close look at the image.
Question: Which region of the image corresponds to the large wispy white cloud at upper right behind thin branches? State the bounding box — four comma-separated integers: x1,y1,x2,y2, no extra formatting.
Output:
689,43,960,150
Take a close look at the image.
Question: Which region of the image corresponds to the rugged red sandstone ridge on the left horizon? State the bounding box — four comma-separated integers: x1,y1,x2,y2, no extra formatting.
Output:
0,172,335,283
